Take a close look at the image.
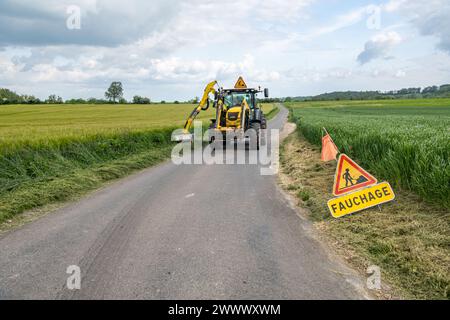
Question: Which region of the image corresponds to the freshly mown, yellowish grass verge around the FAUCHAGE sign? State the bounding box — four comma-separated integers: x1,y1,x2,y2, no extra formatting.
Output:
281,131,450,299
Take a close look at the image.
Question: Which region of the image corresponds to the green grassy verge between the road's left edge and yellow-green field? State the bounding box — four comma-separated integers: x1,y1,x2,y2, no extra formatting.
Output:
0,128,173,222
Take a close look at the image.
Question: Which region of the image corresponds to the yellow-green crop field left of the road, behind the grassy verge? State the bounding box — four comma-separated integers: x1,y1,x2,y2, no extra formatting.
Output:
0,104,212,147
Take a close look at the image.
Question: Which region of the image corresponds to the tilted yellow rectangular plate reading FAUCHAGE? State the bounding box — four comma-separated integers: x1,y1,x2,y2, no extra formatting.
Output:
328,182,395,218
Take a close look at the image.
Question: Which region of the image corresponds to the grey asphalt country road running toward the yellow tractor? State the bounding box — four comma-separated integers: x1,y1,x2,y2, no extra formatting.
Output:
0,108,365,299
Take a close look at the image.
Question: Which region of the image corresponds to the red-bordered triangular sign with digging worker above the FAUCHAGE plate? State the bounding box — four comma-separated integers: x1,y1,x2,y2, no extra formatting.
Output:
333,154,377,196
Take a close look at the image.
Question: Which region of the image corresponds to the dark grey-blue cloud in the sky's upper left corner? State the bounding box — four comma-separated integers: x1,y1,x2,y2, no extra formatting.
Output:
0,0,181,47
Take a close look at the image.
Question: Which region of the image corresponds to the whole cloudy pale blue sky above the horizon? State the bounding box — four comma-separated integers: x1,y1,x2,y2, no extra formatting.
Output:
0,0,450,101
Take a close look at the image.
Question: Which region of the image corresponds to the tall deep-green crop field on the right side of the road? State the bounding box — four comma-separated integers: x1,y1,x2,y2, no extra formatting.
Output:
288,99,450,208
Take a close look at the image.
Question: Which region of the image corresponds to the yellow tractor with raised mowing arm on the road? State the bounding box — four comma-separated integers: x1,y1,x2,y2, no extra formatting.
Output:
179,77,269,149
